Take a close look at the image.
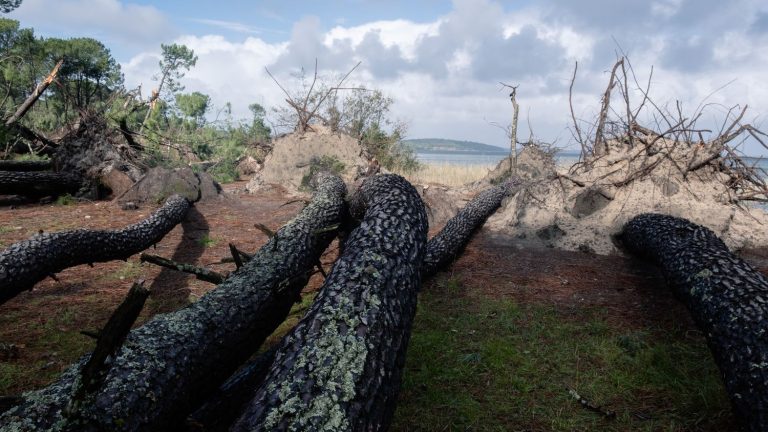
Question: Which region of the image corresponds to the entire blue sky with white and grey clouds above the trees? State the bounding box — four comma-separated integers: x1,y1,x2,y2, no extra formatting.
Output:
10,0,768,154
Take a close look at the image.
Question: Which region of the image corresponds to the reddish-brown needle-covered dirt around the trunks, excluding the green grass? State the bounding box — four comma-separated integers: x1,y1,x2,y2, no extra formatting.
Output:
0,182,768,428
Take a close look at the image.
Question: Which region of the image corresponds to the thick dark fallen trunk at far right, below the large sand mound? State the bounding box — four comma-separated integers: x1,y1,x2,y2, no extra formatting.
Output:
619,214,768,431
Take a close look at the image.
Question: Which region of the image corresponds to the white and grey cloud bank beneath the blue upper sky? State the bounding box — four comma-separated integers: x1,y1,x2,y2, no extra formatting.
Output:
114,0,768,154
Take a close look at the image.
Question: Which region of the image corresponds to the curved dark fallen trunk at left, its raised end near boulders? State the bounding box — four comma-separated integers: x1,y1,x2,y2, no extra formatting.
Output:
0,195,191,305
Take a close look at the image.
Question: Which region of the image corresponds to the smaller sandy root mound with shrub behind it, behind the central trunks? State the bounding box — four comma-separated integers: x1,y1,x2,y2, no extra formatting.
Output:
246,125,368,192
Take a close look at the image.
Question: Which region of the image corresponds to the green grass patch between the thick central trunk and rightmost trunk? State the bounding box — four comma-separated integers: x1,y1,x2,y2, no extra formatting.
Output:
392,279,733,431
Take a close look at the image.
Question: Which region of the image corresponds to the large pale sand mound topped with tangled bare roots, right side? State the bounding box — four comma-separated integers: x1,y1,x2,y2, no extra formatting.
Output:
486,140,768,254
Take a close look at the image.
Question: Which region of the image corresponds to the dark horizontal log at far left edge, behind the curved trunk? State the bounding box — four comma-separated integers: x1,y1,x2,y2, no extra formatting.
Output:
0,171,83,196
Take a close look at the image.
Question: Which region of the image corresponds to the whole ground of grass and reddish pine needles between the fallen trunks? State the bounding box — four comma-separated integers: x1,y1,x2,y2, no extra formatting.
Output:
0,182,768,431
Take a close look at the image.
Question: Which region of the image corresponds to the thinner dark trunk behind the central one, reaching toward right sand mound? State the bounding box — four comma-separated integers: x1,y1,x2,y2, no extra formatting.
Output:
421,177,522,278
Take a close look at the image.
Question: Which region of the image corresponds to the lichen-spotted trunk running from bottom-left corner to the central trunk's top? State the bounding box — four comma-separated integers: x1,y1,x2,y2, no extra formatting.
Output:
0,176,346,431
